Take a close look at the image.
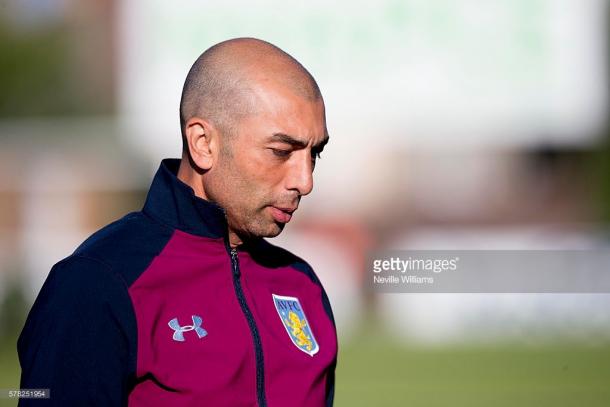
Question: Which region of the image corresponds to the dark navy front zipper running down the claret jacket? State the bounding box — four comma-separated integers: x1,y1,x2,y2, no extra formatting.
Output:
227,245,267,407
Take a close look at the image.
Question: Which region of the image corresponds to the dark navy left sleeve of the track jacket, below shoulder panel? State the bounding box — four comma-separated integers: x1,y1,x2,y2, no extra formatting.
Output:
17,255,137,407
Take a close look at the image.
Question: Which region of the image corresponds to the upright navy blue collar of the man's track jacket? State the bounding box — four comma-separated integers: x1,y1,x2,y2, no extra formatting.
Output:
142,158,227,238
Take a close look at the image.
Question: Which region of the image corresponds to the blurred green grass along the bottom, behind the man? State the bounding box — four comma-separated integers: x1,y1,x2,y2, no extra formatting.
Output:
0,326,610,407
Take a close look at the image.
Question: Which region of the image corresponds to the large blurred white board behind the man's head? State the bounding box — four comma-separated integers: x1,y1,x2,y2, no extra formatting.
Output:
117,0,607,163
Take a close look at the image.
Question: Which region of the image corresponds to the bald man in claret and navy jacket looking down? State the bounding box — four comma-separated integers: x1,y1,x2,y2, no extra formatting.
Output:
18,38,337,407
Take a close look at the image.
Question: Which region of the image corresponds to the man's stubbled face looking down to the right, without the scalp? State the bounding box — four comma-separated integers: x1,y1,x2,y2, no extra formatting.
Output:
207,83,328,241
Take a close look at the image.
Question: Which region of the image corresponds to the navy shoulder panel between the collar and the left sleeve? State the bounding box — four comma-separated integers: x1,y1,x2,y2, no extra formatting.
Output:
72,212,174,286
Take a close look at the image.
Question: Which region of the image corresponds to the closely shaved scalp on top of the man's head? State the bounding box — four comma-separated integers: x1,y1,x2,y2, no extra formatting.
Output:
180,38,322,151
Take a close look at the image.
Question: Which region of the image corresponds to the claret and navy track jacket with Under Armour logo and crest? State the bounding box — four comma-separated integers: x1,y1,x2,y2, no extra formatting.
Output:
17,159,337,407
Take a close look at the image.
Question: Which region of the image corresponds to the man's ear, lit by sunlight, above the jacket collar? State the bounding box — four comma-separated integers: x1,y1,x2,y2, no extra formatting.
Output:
185,117,218,170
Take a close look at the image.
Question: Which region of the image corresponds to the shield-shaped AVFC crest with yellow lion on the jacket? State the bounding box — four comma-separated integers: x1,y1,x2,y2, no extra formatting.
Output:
271,294,320,356
